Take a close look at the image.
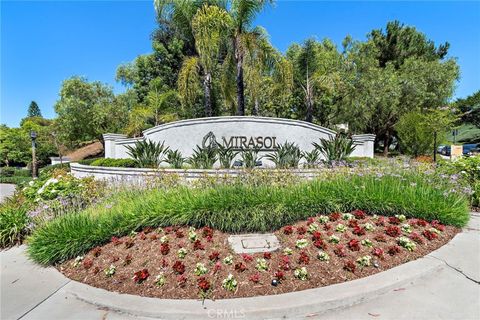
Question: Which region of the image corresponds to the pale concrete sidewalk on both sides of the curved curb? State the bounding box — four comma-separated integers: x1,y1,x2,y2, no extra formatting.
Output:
0,214,480,320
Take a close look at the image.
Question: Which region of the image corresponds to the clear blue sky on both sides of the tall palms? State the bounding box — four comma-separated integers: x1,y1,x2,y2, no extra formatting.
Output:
0,0,480,126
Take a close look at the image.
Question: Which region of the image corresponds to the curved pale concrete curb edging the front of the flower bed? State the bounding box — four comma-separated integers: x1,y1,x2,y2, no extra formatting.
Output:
64,254,445,320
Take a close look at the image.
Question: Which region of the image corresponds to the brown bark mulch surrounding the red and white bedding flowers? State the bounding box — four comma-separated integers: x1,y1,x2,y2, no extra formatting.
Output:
57,216,460,299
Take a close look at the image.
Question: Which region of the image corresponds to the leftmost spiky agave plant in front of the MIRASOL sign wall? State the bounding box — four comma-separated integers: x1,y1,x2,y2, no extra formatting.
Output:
126,140,169,168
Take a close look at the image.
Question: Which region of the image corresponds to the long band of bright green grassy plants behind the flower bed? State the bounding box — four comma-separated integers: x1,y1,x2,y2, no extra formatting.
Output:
28,175,469,264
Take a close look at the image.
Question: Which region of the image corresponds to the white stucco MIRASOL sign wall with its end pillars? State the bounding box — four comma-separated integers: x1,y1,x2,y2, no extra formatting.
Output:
103,117,375,166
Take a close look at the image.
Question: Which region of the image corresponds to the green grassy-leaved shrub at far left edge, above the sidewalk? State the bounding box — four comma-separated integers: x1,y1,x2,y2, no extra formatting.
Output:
0,203,29,248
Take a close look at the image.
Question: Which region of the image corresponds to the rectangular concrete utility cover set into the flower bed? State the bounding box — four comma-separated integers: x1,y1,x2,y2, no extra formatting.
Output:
228,233,280,253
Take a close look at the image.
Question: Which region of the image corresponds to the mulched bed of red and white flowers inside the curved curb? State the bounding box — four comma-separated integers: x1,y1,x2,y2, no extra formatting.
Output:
57,210,459,299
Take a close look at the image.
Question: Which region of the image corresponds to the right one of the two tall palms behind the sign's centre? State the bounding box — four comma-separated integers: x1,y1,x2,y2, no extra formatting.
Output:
230,0,273,116
